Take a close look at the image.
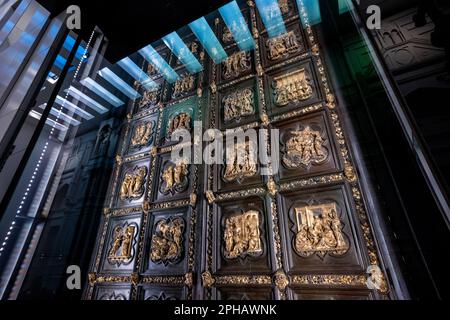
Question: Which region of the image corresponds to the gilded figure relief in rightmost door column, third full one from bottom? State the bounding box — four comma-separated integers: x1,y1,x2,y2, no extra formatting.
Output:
272,68,313,107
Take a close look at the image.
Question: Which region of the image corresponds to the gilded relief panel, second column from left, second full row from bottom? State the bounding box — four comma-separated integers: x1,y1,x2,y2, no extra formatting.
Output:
153,152,192,202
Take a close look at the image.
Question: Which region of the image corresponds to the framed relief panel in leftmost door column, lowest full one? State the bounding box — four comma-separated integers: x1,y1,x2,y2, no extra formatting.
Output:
100,215,141,273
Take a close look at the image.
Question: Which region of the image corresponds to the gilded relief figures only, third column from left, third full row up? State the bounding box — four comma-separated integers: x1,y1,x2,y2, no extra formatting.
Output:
222,88,255,122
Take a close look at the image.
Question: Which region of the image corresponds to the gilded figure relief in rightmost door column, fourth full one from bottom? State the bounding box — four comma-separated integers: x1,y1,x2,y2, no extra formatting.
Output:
266,31,303,61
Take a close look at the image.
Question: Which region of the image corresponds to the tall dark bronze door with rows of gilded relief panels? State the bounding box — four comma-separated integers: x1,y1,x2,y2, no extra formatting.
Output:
85,0,389,300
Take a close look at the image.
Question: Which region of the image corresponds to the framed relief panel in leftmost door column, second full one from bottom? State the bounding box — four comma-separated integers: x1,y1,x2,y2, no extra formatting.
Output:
116,159,150,208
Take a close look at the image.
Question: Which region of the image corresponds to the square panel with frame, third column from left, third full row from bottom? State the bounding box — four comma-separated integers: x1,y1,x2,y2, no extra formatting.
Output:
217,78,259,130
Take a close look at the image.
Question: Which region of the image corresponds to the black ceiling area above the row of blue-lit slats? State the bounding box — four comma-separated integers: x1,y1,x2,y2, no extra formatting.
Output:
38,0,231,63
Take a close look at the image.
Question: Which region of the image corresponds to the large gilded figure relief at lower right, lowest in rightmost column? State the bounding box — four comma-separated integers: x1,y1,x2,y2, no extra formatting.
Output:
294,202,349,257
